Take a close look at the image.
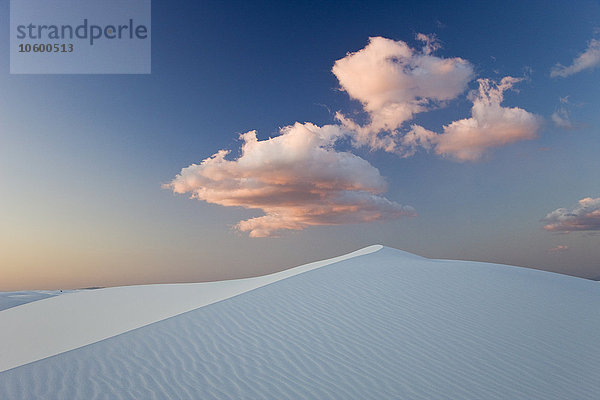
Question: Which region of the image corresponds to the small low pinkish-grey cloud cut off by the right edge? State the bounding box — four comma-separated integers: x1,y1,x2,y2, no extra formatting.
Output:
543,197,600,233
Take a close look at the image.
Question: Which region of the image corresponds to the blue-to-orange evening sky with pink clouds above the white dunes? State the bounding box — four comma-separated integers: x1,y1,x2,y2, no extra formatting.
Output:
0,0,600,290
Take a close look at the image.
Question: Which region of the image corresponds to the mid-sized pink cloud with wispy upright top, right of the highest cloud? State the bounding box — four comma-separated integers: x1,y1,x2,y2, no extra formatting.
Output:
410,76,541,161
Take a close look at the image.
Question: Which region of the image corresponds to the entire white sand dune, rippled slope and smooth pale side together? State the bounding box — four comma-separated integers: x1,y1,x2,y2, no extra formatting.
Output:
0,246,600,400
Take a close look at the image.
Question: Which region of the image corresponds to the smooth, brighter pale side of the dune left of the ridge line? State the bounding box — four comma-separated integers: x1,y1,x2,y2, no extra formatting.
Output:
0,245,382,372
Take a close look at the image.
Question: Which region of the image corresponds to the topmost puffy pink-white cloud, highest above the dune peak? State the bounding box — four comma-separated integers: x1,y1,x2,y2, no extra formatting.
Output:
332,34,473,148
